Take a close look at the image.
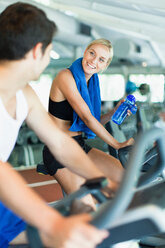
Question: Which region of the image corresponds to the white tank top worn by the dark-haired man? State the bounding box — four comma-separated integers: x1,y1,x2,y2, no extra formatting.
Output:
0,90,28,162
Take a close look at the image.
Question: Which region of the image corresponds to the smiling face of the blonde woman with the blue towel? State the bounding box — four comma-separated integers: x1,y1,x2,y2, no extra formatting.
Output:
82,44,110,76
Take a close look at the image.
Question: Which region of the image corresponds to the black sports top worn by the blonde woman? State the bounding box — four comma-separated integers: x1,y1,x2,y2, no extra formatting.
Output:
48,98,73,121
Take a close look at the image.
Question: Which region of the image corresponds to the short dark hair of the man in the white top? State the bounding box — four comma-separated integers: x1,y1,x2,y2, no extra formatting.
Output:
0,2,57,60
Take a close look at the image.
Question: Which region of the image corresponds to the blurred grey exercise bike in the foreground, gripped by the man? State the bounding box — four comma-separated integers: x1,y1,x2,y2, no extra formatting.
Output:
27,128,165,248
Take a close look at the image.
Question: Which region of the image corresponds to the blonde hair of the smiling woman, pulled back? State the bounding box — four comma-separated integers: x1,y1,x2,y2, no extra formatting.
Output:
86,38,113,68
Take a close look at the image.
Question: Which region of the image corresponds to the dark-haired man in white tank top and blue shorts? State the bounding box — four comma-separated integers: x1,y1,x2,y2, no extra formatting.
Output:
0,2,107,248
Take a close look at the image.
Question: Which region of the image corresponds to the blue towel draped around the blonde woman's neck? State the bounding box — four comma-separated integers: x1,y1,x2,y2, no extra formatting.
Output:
69,58,101,139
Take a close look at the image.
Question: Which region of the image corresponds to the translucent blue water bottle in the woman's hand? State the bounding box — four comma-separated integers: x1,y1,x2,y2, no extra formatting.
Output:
112,95,137,125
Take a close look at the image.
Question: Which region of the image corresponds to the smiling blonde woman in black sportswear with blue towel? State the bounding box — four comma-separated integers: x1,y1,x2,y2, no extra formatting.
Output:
38,39,133,202
